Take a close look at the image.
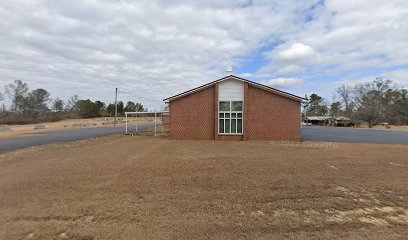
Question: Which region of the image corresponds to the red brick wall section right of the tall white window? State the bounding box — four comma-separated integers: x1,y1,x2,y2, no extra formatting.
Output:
244,84,301,141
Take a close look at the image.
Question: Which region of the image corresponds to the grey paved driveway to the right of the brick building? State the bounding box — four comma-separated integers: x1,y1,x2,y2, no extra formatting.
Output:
302,126,408,145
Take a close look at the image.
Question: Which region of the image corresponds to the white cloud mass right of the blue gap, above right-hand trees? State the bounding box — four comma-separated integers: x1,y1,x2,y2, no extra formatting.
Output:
255,0,408,97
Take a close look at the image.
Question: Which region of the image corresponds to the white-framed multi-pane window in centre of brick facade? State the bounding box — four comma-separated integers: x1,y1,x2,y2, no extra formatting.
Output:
218,101,243,135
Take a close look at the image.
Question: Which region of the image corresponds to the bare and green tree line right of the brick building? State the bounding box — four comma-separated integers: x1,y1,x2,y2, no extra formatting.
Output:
302,77,408,127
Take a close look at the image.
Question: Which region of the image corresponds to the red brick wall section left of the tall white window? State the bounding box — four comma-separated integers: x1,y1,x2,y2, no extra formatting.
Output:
169,86,216,140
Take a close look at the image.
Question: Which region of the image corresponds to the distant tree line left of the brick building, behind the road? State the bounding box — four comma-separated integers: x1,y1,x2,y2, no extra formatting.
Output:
0,80,147,124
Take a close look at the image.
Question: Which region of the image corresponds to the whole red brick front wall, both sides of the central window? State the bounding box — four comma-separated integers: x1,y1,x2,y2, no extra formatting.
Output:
169,83,301,141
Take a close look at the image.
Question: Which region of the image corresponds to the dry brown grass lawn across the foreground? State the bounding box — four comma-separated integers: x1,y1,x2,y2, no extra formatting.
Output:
0,136,408,239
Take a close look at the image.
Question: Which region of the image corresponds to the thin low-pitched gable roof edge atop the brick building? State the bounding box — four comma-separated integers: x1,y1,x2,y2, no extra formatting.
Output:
163,75,306,102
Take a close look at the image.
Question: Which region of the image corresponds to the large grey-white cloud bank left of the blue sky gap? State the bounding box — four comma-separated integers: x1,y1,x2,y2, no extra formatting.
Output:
0,0,318,108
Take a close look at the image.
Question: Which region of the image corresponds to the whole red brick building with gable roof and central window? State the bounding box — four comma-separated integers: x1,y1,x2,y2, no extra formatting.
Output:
164,75,304,141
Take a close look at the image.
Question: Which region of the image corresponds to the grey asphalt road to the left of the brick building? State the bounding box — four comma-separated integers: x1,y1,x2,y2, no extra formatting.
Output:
0,124,154,153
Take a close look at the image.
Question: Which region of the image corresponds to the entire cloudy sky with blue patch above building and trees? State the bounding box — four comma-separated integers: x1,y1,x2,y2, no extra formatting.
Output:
0,0,408,109
